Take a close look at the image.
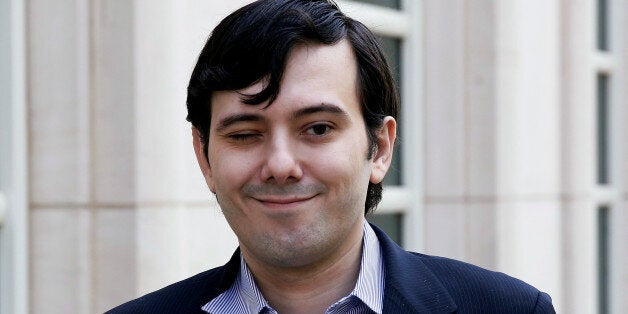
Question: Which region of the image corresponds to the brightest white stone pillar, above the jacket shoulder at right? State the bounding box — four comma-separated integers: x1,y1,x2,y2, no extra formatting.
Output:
495,0,562,311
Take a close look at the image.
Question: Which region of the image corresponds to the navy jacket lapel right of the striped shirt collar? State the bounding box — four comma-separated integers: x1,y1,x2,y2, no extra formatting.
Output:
371,225,457,313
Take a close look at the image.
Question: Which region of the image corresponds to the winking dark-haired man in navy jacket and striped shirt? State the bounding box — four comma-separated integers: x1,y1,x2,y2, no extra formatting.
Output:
111,0,553,313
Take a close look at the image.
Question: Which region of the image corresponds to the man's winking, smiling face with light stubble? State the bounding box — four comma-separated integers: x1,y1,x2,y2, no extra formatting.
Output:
197,40,394,267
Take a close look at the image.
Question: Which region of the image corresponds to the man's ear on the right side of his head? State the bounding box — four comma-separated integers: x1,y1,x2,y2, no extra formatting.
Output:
371,116,397,184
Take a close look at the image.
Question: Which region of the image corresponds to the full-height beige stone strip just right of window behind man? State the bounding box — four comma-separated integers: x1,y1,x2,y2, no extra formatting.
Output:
423,0,467,260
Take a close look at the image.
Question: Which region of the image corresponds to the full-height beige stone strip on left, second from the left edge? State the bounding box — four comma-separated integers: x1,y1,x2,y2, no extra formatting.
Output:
89,0,139,313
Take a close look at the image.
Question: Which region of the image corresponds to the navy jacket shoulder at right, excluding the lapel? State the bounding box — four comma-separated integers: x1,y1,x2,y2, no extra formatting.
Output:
410,252,554,313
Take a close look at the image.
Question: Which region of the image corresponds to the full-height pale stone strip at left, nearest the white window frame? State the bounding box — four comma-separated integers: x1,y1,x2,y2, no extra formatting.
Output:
26,0,93,313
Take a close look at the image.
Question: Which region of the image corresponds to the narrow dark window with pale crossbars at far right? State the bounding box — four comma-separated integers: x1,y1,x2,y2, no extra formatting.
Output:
593,0,622,314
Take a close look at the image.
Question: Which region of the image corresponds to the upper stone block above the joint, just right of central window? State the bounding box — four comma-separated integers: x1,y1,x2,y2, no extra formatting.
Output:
423,1,466,196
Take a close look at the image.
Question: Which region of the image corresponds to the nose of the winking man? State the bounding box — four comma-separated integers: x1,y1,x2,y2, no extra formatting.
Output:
261,134,303,184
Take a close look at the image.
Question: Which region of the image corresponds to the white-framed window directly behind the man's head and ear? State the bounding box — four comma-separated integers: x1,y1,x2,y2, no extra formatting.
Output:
338,0,423,251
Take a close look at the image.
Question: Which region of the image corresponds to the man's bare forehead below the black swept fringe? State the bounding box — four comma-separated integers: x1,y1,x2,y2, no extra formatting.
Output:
211,40,361,123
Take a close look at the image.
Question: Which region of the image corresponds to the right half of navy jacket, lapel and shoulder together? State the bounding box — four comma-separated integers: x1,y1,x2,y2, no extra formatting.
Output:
373,227,554,313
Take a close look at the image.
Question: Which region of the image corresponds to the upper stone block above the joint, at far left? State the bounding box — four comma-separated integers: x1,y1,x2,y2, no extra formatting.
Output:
26,0,89,203
